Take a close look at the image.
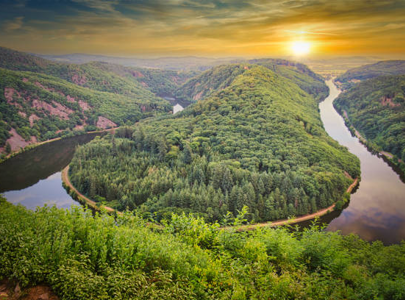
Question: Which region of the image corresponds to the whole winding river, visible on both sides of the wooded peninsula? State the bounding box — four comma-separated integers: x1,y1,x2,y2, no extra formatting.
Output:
0,81,405,244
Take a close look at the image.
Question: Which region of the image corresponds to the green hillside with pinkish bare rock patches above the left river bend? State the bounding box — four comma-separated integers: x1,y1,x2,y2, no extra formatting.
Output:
0,68,170,150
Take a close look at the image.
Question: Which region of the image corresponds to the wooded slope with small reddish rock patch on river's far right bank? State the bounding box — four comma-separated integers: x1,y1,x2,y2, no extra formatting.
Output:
334,75,405,161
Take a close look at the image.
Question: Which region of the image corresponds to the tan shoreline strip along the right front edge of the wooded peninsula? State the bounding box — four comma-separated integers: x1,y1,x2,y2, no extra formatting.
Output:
223,178,359,231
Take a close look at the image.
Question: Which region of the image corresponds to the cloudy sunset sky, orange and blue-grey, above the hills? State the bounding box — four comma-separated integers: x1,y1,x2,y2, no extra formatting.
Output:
0,0,405,57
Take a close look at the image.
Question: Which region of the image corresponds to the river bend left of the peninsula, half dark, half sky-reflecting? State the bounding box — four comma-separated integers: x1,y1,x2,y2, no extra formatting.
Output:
0,133,100,209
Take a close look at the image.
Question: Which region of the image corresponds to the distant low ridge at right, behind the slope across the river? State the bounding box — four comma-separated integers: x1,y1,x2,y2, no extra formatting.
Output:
335,60,405,89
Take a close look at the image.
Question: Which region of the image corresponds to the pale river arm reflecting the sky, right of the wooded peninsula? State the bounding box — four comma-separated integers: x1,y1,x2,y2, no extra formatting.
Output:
319,81,405,244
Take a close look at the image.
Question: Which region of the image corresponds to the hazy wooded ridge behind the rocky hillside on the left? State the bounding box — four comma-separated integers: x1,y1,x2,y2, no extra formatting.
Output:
0,47,195,98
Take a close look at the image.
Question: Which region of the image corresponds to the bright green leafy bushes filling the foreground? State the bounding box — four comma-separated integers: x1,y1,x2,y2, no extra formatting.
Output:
0,197,405,300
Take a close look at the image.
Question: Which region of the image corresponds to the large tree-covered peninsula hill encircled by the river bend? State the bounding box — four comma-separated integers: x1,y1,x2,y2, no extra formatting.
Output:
71,65,360,221
